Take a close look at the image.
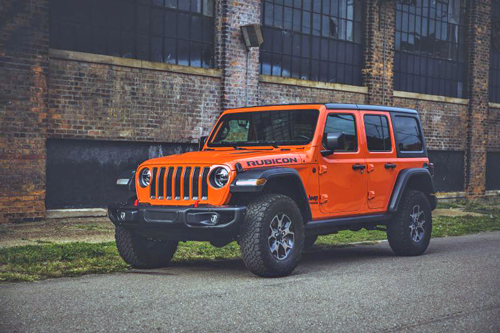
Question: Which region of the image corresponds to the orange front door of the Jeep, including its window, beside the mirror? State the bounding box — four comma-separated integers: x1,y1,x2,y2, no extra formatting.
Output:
318,110,366,216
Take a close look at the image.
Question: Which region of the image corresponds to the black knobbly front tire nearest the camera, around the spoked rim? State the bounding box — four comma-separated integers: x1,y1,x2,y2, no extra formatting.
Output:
240,194,304,277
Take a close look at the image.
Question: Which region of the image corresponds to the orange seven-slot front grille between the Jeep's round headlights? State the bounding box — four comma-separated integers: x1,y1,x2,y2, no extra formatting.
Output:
149,166,210,200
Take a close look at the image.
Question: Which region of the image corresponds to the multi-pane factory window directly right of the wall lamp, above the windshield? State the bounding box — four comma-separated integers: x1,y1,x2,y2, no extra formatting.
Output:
260,0,363,85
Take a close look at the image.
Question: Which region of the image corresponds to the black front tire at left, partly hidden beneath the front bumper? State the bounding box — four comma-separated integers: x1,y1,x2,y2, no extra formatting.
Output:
115,226,179,268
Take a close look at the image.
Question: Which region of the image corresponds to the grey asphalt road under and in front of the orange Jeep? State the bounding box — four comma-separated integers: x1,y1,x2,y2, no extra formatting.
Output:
0,232,500,332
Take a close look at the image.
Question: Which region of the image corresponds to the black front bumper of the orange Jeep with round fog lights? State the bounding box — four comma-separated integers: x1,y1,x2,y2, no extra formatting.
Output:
108,204,246,238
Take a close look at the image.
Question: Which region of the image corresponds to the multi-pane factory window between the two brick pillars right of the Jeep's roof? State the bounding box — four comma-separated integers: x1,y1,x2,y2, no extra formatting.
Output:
394,0,467,98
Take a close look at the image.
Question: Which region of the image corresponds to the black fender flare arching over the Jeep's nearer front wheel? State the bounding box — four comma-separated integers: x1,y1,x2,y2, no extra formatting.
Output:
230,167,312,223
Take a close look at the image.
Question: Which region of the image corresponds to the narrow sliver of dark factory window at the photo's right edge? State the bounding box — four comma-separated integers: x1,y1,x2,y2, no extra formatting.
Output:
490,0,500,103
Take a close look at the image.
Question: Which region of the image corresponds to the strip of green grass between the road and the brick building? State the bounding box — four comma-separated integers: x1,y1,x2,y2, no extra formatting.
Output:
0,198,500,282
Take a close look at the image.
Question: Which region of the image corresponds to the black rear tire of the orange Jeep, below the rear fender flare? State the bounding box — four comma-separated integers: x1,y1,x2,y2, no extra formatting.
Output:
387,189,432,256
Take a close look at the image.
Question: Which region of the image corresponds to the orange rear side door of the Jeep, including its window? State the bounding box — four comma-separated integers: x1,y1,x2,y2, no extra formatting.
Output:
361,111,401,210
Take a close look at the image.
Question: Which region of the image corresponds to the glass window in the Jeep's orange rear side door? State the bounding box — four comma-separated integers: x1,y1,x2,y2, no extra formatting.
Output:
364,115,392,151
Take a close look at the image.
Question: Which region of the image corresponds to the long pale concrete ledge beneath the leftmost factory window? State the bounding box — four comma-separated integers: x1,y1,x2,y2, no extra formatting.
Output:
49,49,222,78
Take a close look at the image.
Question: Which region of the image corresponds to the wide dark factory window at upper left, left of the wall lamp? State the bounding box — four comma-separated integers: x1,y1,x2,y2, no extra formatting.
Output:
50,0,215,67
